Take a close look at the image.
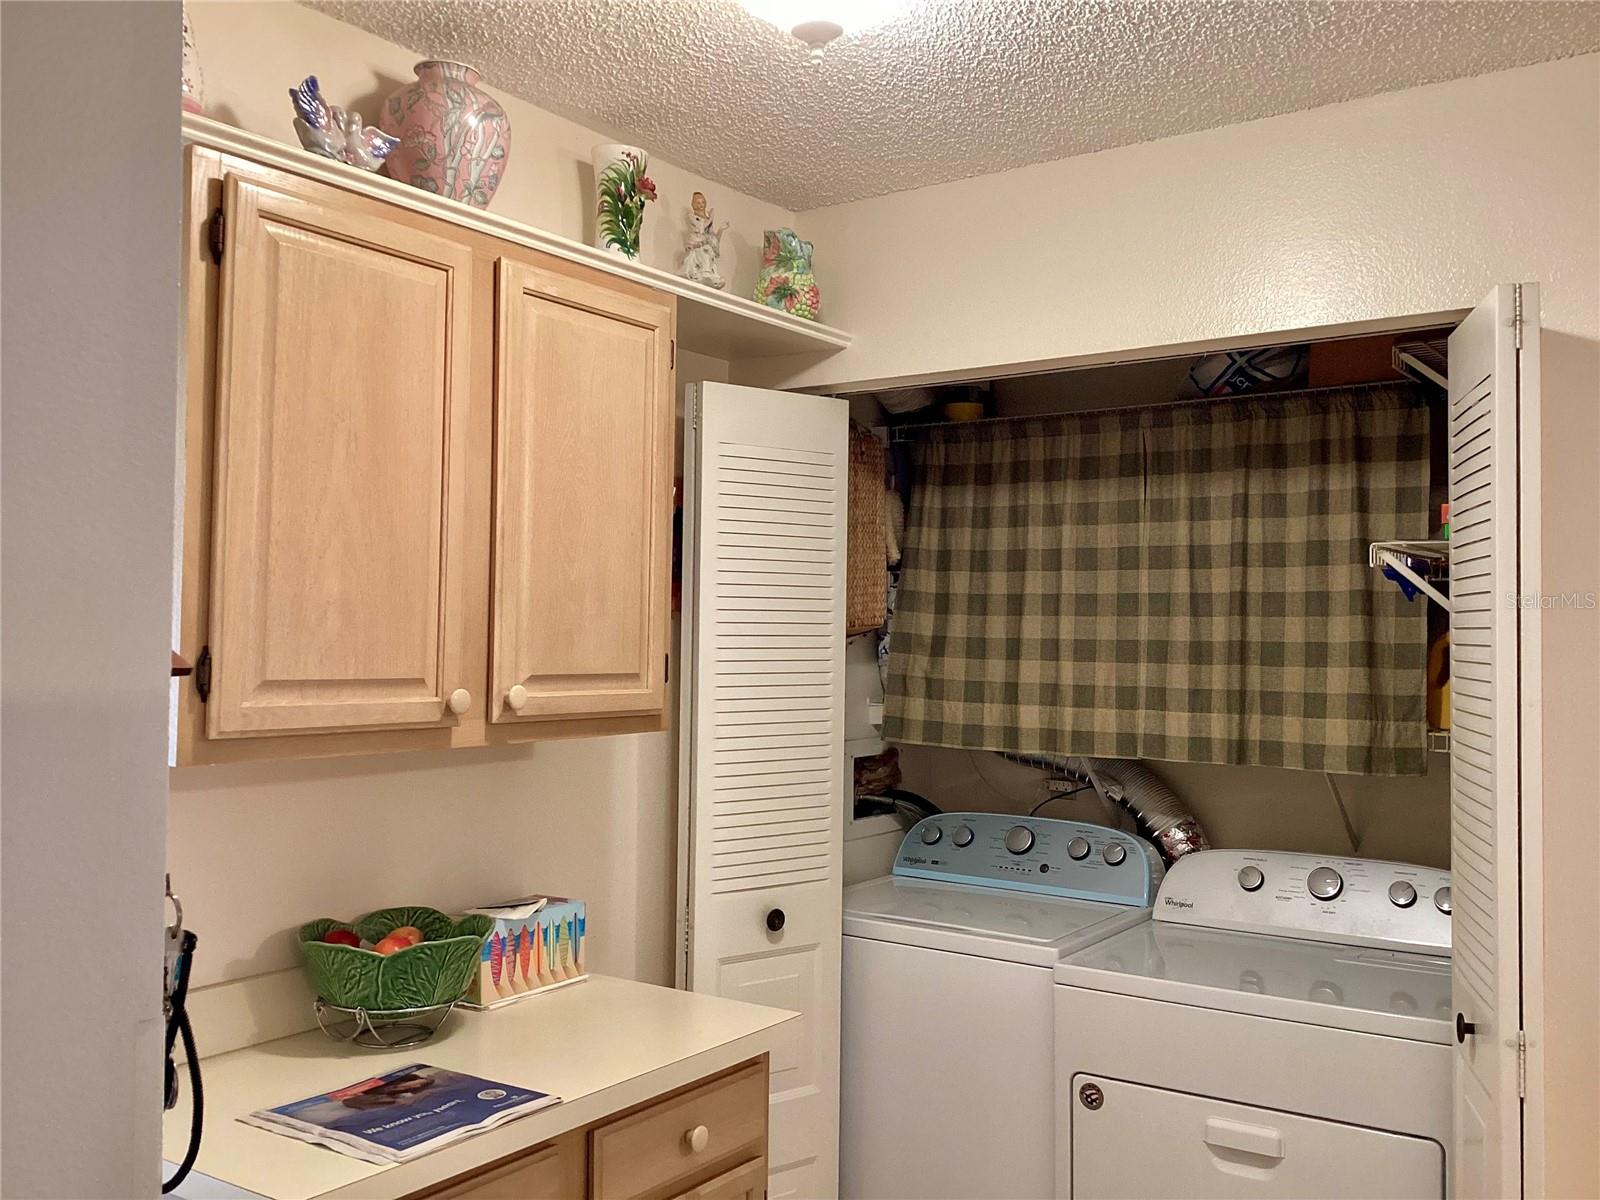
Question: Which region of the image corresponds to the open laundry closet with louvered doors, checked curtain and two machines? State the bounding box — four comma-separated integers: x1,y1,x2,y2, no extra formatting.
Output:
680,286,1538,1200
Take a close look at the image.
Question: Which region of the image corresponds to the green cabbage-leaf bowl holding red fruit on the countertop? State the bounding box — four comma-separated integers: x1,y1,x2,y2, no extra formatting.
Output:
299,906,494,1013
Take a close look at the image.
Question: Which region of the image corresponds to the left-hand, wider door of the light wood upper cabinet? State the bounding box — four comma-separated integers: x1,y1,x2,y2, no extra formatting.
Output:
208,176,472,738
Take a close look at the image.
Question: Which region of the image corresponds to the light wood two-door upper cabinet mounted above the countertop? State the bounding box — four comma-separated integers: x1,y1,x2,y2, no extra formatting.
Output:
176,147,675,765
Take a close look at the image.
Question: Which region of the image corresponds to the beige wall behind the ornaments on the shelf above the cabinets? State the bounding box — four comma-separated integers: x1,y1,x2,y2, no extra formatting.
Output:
189,0,795,296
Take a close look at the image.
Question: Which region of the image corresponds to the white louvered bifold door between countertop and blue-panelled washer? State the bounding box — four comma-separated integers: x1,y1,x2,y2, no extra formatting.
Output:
680,384,850,1200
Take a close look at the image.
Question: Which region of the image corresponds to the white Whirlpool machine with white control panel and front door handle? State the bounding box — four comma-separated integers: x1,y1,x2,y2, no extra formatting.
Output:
1056,850,1454,1200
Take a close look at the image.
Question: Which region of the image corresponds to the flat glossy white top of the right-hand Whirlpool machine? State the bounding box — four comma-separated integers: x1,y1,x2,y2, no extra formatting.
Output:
1056,922,1454,1043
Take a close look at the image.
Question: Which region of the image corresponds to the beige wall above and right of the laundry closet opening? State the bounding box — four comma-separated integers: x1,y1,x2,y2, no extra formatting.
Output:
764,54,1600,1197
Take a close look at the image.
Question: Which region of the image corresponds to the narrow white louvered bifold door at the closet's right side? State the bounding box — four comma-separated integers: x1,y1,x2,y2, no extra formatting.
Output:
1450,285,1539,1197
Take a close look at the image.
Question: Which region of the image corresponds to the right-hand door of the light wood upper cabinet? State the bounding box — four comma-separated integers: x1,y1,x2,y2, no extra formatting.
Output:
490,258,672,722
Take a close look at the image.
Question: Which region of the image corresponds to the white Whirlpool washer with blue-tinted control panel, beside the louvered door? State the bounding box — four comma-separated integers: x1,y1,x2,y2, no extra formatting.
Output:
840,813,1162,1200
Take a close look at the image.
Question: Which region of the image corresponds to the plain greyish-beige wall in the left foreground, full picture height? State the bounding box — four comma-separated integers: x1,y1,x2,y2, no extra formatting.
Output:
0,3,182,1200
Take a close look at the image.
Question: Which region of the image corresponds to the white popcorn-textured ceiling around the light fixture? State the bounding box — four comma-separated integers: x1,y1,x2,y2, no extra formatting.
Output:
309,0,1600,209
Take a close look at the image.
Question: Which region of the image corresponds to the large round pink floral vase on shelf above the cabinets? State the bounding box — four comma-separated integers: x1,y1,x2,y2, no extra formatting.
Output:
378,59,510,208
